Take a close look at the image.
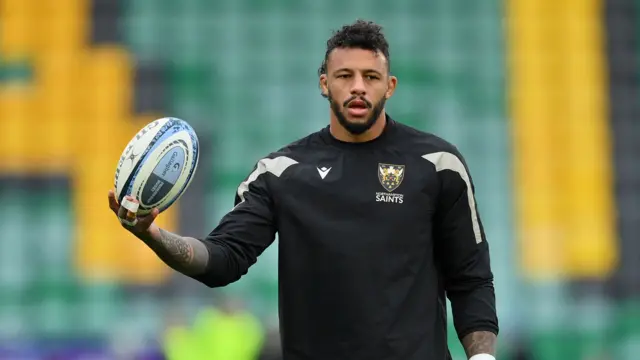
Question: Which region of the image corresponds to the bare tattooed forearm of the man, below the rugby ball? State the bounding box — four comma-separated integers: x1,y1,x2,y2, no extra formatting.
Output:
141,227,209,276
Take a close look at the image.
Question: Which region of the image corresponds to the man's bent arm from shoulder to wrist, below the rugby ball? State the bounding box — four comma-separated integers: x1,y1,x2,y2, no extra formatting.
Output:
133,157,295,287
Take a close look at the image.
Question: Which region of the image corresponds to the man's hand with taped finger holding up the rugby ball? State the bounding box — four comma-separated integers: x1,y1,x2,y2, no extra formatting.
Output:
109,190,160,240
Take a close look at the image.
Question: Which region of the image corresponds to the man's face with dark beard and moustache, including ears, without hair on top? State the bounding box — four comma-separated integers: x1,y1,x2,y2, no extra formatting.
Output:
320,48,397,135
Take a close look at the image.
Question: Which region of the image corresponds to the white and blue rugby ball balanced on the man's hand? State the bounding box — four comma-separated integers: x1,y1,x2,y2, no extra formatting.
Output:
115,117,200,215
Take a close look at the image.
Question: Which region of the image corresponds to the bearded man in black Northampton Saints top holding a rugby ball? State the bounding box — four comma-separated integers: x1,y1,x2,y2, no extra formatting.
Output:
109,21,498,360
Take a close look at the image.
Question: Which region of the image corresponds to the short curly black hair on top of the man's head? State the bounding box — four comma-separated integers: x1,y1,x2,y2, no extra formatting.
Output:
318,20,390,76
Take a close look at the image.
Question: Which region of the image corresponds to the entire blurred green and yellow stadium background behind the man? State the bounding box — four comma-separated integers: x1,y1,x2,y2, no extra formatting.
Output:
0,0,640,360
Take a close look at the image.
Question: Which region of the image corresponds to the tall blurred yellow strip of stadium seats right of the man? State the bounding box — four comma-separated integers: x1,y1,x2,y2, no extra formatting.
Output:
507,0,616,278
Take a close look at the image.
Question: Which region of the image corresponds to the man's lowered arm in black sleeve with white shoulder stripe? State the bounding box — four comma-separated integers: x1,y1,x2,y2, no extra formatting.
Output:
424,149,498,358
